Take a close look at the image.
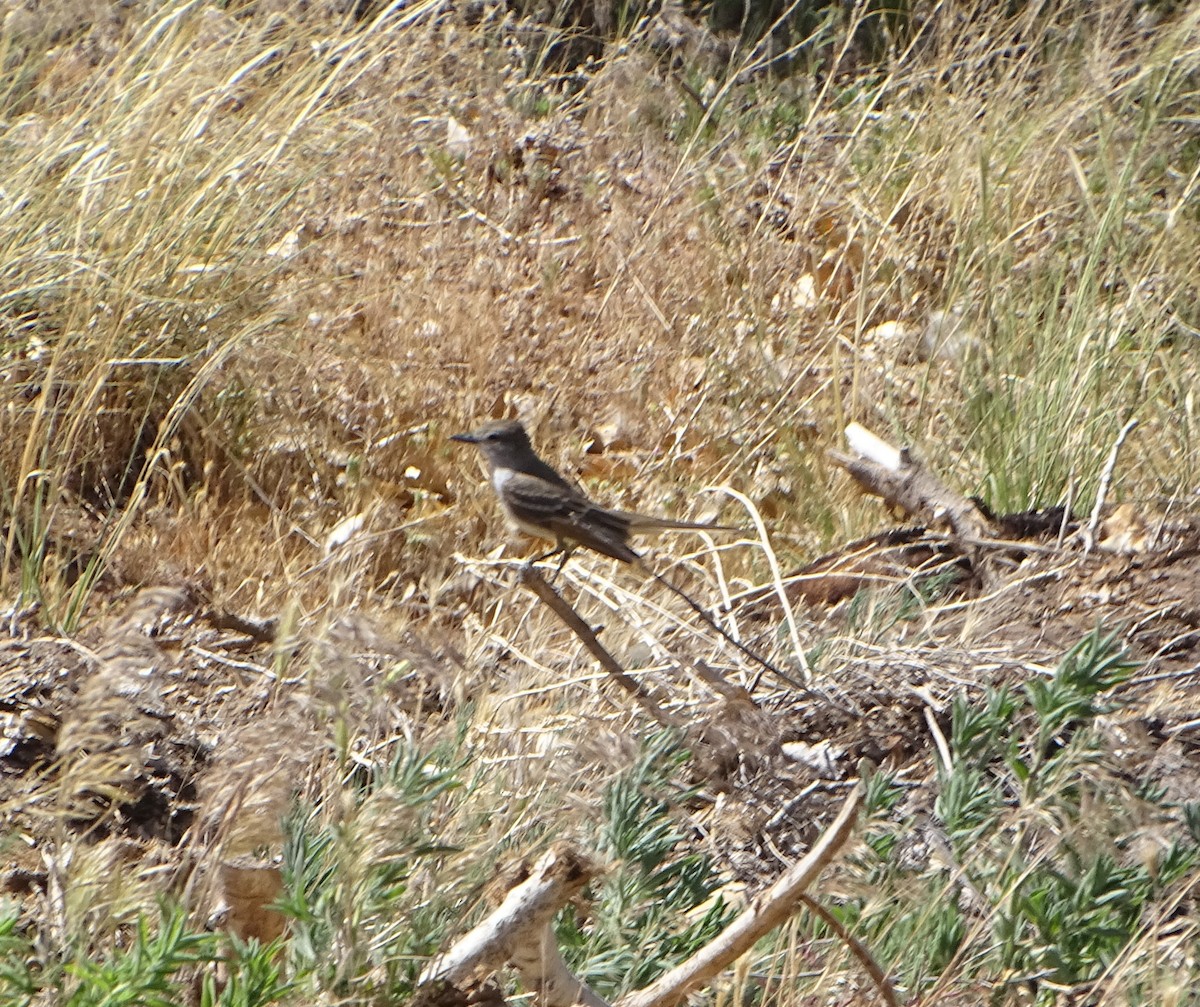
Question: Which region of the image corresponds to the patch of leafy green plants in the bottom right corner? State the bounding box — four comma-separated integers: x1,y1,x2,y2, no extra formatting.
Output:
842,628,1200,1003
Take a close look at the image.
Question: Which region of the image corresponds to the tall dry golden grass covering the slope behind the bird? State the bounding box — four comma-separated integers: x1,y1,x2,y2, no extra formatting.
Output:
0,5,1196,615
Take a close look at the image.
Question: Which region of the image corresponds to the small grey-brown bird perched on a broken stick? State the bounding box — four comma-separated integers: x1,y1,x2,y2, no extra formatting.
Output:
450,420,738,565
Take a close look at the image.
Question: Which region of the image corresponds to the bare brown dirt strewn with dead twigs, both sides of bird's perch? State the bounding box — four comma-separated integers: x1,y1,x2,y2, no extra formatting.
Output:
0,496,1200,911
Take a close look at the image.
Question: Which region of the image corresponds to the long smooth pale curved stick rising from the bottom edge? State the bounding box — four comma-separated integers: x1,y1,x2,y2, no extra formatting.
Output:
617,784,863,1007
